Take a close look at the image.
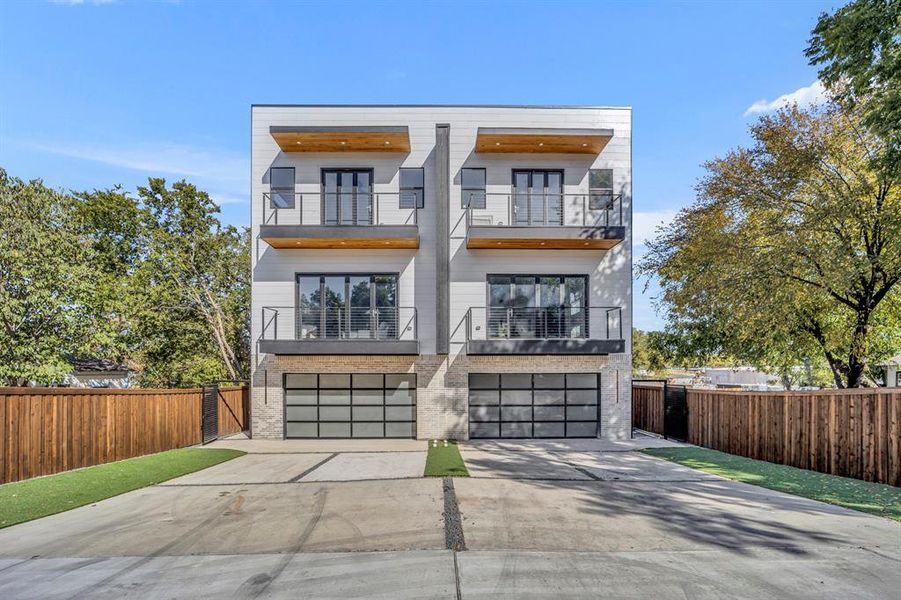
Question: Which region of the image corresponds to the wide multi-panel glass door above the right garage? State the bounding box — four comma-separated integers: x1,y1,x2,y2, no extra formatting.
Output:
488,275,588,339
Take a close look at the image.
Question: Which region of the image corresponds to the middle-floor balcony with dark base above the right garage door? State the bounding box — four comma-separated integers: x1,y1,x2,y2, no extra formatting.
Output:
466,306,626,355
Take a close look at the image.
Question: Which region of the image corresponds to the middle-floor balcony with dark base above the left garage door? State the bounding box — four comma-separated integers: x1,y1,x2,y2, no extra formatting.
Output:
258,306,419,355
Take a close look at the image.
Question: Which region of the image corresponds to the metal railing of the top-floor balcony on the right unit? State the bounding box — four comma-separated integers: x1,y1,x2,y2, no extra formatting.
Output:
464,192,625,227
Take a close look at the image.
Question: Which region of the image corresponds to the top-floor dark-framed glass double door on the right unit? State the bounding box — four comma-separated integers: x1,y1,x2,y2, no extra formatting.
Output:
513,170,563,226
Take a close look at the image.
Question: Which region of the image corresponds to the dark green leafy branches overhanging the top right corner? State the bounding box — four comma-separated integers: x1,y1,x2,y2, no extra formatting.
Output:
806,0,901,154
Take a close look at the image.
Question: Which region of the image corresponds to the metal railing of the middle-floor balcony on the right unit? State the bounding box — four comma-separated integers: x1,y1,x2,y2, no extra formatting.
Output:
466,306,623,341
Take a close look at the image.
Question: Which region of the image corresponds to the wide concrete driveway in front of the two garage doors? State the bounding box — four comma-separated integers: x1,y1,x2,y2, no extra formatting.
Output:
0,439,901,598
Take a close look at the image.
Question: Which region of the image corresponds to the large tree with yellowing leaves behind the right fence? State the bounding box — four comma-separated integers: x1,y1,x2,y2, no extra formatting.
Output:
639,105,901,387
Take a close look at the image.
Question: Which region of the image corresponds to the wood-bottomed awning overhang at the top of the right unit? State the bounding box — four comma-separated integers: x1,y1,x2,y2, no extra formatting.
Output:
476,127,613,154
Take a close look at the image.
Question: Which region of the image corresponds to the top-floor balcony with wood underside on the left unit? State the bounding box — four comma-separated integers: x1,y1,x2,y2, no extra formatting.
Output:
260,191,419,249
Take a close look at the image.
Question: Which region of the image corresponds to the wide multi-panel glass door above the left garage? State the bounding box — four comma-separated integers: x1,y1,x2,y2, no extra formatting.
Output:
297,274,398,340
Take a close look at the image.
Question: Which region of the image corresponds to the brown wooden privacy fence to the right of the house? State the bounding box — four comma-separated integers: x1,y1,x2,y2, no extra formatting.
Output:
632,386,901,486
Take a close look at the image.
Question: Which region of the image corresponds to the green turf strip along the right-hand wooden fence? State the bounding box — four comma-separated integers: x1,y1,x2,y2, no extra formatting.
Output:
642,448,901,521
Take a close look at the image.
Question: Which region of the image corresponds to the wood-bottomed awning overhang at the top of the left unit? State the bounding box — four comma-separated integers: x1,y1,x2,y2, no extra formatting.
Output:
269,125,410,152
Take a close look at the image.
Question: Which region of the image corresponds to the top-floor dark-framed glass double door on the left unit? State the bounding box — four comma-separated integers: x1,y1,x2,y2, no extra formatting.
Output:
321,169,373,225
